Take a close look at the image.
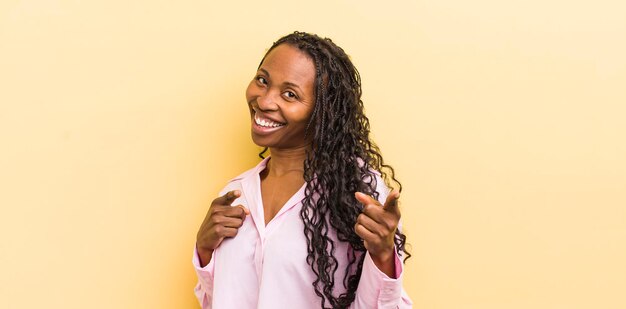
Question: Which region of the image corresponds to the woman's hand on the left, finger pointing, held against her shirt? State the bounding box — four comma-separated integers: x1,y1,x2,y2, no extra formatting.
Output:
196,190,250,267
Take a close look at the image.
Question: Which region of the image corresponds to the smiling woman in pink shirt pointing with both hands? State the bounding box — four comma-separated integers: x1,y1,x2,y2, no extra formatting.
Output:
193,32,411,308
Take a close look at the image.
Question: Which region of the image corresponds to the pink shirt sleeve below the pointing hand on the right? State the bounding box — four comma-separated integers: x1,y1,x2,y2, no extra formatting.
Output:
350,250,413,309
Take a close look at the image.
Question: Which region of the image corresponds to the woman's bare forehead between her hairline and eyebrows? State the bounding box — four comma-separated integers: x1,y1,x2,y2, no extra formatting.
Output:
261,44,315,88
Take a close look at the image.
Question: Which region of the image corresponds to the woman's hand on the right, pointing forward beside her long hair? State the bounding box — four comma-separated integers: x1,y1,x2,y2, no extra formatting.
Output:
354,190,400,278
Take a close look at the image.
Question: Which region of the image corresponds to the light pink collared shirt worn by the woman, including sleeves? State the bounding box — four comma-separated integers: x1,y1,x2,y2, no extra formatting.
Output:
193,157,412,309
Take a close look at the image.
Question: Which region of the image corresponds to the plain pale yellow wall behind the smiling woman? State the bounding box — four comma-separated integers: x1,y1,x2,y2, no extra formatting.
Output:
0,0,626,309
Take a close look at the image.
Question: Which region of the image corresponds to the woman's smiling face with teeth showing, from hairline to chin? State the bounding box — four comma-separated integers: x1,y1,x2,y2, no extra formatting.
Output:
246,44,315,149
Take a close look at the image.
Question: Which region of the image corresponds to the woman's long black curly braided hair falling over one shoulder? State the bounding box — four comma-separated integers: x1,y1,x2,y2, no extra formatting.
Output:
259,31,411,308
